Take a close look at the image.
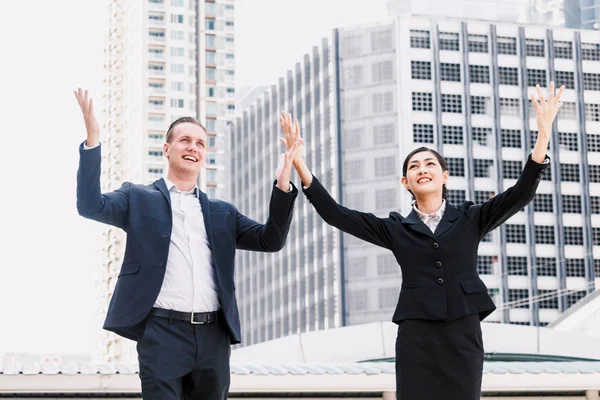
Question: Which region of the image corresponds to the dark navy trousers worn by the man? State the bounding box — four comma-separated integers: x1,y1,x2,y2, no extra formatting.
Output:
137,315,231,400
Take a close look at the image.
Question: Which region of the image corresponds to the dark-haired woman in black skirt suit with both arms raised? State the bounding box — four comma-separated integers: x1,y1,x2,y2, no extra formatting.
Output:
280,82,564,400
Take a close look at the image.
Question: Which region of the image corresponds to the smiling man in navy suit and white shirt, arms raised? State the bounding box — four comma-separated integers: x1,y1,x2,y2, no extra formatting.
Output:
75,89,301,400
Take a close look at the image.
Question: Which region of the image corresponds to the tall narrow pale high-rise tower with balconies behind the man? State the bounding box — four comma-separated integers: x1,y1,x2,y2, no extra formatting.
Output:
98,0,235,361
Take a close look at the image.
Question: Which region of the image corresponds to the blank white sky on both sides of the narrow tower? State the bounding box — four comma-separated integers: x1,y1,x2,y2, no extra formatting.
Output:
0,0,386,354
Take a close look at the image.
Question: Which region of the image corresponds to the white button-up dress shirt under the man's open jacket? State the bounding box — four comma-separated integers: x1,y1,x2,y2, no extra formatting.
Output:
154,178,220,312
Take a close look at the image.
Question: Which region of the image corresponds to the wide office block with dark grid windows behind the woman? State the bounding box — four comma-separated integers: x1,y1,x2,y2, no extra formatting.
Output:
232,16,600,344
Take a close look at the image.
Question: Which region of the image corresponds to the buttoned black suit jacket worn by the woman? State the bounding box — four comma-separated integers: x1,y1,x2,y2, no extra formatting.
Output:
304,157,548,322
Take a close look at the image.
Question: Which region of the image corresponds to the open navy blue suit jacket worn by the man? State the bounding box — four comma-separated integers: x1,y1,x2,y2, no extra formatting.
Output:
77,145,298,343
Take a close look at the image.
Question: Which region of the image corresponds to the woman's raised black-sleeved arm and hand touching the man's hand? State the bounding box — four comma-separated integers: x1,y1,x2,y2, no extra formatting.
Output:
280,113,392,249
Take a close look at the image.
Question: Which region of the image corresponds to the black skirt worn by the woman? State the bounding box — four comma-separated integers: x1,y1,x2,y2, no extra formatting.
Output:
396,314,484,400
